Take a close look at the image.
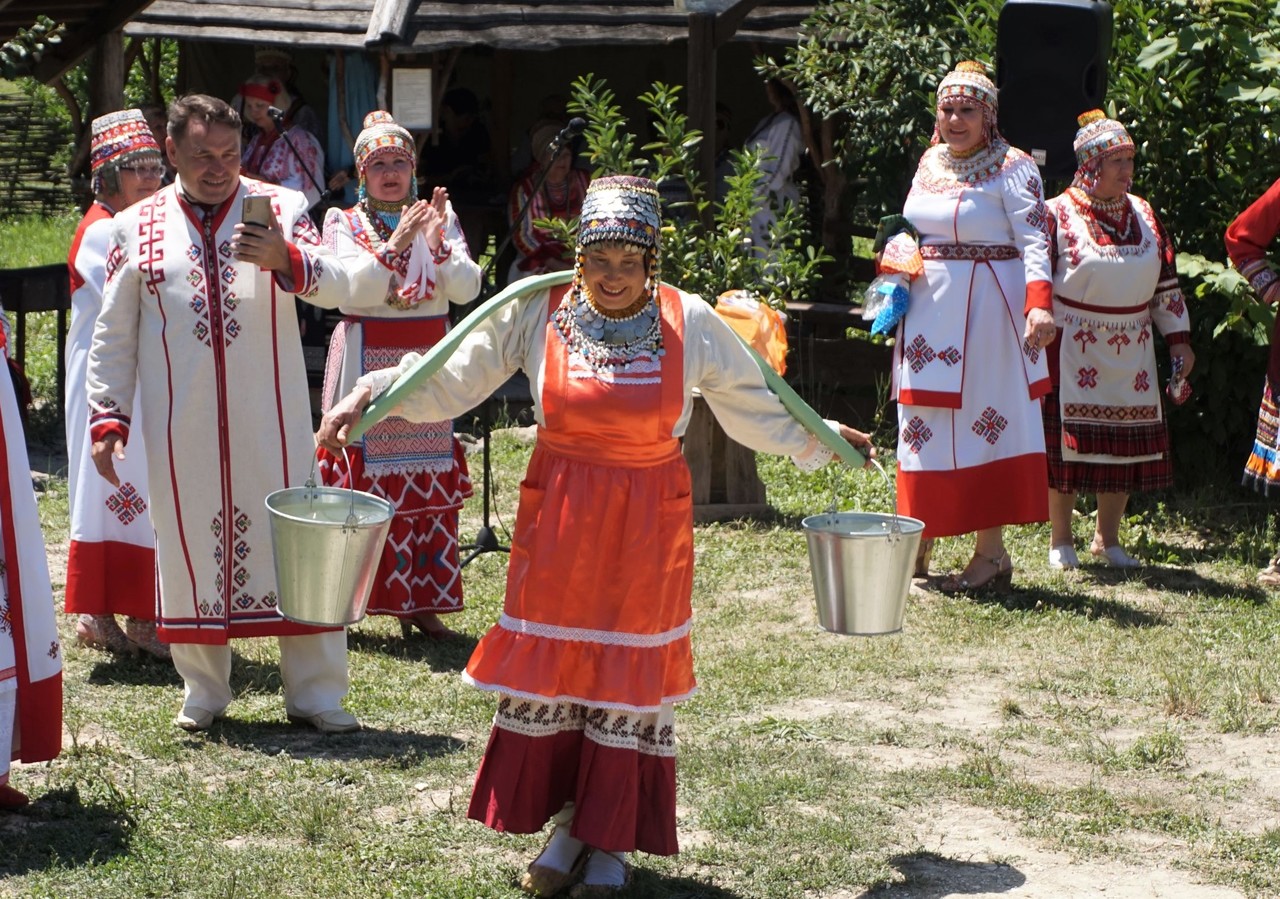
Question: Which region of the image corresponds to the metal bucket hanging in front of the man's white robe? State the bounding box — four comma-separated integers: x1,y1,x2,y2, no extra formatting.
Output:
266,480,394,628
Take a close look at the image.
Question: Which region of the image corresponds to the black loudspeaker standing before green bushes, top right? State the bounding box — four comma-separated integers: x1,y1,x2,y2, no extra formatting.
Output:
996,0,1111,178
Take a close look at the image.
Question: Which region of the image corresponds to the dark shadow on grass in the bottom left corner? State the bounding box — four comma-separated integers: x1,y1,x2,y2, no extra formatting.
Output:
0,786,136,877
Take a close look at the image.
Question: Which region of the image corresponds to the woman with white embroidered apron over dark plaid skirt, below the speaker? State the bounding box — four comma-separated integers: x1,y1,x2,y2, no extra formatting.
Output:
1044,109,1196,569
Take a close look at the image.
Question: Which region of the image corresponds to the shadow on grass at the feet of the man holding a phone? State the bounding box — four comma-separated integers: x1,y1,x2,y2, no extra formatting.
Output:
207,717,466,767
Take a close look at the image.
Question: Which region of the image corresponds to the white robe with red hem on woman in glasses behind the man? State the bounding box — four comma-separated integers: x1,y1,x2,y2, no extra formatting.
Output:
64,202,156,619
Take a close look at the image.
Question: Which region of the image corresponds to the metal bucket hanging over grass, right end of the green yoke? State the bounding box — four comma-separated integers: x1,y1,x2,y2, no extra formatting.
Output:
801,512,924,635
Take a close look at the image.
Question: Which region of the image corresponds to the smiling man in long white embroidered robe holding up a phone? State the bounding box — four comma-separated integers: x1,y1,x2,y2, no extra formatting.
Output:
88,95,360,733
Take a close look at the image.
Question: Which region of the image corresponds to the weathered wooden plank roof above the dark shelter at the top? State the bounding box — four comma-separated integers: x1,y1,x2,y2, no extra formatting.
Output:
127,0,814,53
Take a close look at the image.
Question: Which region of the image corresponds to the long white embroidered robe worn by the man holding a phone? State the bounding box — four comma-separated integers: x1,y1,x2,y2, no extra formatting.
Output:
88,178,348,643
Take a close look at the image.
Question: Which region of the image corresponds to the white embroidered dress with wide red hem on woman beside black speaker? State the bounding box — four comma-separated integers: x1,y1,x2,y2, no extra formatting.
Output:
893,143,1051,537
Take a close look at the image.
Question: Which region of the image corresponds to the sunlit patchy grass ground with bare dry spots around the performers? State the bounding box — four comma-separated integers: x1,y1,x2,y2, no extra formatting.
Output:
0,438,1280,899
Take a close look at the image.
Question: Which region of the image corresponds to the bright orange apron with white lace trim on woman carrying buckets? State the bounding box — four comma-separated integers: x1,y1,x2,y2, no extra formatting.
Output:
467,288,695,711
